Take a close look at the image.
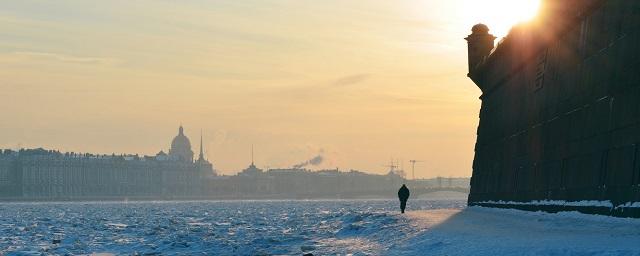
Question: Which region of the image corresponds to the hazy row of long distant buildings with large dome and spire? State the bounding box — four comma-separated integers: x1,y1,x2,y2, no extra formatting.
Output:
0,127,215,200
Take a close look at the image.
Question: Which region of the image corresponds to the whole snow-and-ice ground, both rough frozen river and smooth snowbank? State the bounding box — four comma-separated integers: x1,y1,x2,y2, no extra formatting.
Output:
0,200,640,256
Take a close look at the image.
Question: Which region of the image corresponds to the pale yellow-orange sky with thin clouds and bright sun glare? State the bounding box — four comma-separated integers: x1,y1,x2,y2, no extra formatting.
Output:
0,0,538,178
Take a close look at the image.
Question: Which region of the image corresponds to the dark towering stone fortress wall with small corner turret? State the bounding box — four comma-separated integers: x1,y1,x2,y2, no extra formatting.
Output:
467,0,640,217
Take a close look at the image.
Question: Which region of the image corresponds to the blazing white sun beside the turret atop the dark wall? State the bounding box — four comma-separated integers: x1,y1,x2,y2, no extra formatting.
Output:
463,0,541,38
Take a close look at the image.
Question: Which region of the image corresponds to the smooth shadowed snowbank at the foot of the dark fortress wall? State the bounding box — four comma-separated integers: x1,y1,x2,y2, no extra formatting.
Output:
385,207,640,256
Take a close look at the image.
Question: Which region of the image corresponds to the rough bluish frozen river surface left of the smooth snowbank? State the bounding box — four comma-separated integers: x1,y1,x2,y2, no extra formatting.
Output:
0,200,465,255
